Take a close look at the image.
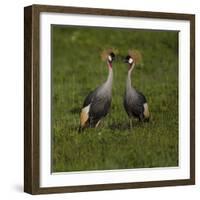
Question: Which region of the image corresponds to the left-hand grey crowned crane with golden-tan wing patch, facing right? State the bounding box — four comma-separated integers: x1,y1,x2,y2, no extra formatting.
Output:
79,50,115,132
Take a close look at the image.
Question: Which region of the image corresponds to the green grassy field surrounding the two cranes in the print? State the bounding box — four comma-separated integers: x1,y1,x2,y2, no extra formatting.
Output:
52,26,178,172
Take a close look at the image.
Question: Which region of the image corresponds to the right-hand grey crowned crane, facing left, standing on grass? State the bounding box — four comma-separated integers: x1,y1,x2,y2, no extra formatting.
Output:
124,51,150,129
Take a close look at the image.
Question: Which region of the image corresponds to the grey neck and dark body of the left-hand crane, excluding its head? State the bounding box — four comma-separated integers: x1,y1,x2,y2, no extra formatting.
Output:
82,65,113,127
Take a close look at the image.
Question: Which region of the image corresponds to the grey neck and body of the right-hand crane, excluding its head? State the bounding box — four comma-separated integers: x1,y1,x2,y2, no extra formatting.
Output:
124,65,149,121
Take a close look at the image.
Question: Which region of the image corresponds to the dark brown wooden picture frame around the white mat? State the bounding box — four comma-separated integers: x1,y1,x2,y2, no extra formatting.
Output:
24,5,195,194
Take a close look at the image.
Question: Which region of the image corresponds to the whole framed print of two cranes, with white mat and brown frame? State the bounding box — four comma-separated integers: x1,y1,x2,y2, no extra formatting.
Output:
24,5,195,194
